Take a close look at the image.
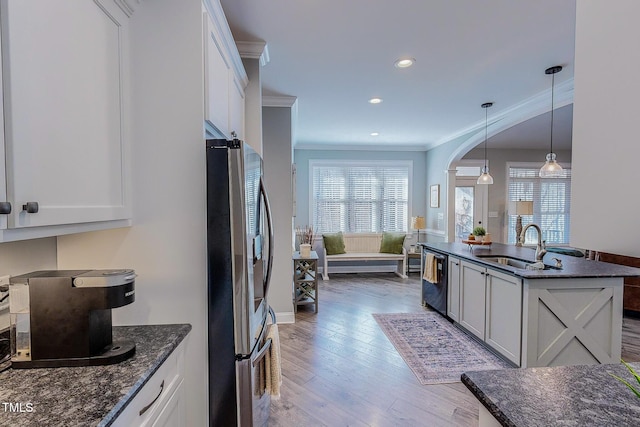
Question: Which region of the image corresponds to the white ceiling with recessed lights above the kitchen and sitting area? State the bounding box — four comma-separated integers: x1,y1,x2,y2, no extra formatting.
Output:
221,0,576,149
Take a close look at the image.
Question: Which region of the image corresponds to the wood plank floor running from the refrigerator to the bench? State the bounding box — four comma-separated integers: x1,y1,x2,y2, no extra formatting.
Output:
269,274,640,427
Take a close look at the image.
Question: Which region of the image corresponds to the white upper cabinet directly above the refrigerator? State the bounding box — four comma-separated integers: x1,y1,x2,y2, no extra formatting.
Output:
202,1,248,139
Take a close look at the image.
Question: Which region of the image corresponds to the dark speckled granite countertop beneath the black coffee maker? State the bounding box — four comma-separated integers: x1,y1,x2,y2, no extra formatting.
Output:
0,324,191,427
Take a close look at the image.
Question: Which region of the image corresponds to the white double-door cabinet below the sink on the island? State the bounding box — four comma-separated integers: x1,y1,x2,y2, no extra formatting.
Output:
459,261,522,366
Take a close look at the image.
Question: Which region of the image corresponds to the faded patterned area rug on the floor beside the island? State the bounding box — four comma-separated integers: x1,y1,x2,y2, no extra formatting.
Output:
373,313,512,385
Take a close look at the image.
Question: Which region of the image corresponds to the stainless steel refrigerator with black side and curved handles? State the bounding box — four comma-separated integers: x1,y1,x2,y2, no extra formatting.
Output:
206,139,275,427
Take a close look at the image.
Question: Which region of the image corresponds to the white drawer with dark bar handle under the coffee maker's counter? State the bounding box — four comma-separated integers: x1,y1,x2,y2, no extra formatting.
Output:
112,345,184,427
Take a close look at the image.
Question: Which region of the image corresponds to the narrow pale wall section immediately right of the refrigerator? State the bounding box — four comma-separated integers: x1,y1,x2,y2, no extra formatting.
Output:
262,107,294,323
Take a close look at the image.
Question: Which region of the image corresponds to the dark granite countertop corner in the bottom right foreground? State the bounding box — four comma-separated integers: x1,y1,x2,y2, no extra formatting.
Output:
462,363,640,427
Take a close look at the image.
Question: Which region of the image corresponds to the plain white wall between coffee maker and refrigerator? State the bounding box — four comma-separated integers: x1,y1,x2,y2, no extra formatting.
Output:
58,0,208,426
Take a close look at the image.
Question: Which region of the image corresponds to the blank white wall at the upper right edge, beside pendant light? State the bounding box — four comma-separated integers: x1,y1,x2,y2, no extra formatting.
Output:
571,0,640,257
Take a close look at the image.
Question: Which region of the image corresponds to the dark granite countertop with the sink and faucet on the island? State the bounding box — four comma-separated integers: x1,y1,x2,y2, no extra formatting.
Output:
418,243,640,279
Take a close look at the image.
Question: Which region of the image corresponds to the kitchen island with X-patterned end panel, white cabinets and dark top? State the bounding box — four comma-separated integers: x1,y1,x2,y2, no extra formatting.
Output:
420,243,640,368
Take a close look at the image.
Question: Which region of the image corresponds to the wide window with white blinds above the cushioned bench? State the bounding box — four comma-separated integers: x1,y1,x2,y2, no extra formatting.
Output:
309,160,412,233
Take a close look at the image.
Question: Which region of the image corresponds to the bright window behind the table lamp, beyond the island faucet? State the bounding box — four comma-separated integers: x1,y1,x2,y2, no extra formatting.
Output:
507,163,571,245
